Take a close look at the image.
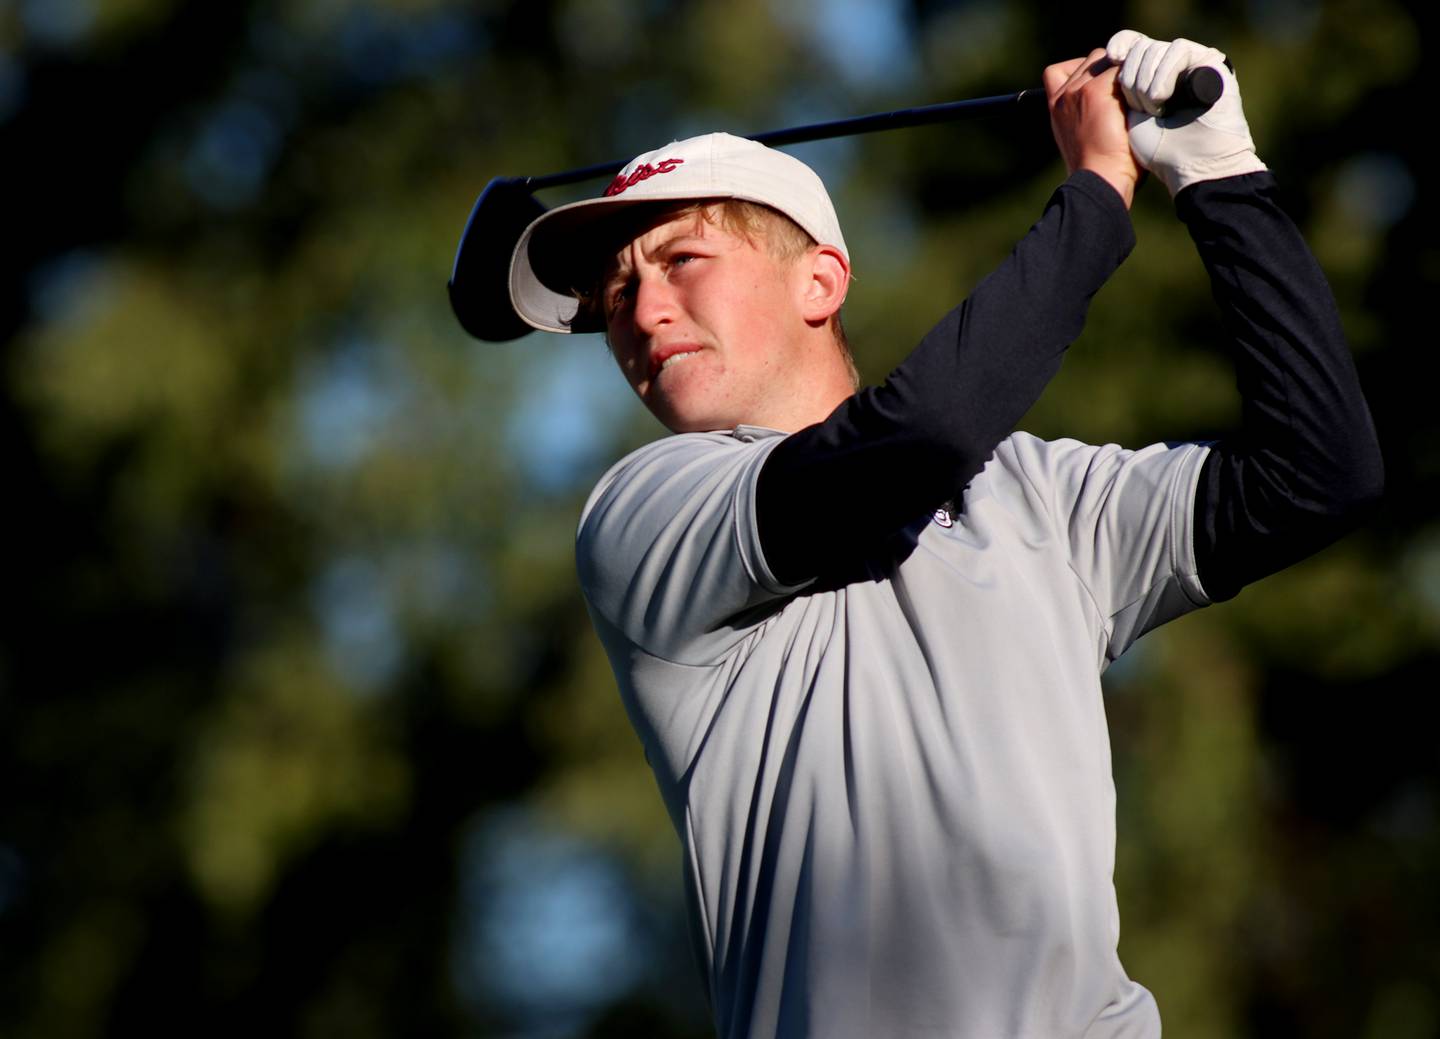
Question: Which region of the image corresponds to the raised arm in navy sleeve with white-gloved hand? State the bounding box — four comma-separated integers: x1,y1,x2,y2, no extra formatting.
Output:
1109,32,1384,600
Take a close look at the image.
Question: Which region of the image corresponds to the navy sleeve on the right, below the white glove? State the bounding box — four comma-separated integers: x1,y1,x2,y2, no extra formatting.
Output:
1175,173,1384,602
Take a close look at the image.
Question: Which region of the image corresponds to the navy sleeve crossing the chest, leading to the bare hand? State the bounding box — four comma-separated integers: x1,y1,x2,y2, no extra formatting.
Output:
756,170,1135,584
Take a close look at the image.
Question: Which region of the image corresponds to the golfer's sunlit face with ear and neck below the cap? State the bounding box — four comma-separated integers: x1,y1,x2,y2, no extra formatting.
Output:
602,213,852,433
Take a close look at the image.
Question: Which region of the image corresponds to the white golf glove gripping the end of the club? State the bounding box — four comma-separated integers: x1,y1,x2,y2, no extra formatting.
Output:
1104,29,1266,197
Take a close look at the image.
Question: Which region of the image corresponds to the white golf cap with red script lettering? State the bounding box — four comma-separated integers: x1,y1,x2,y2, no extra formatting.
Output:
510,134,850,332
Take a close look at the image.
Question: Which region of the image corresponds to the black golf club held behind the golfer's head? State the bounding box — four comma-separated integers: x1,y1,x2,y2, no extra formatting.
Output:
448,66,1224,342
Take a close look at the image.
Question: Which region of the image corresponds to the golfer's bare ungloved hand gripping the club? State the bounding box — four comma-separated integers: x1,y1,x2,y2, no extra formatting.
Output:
1044,47,1143,209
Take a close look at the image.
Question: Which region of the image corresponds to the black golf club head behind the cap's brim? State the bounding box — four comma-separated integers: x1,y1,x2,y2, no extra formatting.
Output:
449,177,546,342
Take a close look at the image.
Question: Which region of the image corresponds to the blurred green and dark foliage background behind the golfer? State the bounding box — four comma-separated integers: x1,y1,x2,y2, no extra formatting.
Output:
0,0,1440,1039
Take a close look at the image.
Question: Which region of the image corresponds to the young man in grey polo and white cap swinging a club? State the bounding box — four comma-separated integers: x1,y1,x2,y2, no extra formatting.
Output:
511,32,1380,1039
